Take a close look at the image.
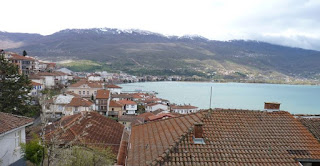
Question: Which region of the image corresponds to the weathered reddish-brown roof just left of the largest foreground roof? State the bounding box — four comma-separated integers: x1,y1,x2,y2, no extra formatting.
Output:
44,111,128,165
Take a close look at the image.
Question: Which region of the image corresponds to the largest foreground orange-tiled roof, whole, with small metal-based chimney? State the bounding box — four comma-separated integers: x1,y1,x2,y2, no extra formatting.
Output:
127,109,320,166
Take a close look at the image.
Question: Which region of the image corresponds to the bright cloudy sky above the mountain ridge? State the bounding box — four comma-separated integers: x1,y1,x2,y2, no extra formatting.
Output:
0,0,320,50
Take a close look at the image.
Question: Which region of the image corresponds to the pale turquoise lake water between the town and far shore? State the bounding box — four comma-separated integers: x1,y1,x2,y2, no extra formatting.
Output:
120,82,320,114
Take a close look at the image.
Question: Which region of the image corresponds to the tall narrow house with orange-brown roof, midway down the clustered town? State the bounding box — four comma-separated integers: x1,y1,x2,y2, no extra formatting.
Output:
96,89,111,116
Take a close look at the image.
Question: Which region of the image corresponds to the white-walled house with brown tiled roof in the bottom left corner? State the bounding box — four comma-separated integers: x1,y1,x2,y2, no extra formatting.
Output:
0,112,33,165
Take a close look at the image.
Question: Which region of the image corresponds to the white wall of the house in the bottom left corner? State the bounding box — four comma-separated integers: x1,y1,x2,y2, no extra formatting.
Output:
0,127,26,166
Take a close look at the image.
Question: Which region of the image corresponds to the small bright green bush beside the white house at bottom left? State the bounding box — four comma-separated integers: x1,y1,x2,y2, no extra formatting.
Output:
21,134,45,165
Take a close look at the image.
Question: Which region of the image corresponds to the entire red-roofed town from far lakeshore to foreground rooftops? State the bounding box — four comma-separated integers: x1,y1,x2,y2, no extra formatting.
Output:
0,50,320,166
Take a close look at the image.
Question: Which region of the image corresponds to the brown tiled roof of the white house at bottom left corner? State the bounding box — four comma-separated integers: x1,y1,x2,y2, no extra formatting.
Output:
0,112,34,134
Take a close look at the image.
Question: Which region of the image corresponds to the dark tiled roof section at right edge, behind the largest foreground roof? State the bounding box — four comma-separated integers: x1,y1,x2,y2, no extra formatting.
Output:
299,117,320,142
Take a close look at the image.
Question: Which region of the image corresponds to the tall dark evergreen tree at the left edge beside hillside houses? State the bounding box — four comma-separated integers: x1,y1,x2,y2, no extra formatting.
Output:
0,52,38,116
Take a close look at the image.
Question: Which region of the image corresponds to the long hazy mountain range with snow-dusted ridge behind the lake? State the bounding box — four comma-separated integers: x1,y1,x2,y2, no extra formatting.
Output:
0,28,320,82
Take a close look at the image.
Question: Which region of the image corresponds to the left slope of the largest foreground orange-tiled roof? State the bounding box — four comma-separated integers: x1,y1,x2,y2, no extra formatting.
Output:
127,112,203,166
